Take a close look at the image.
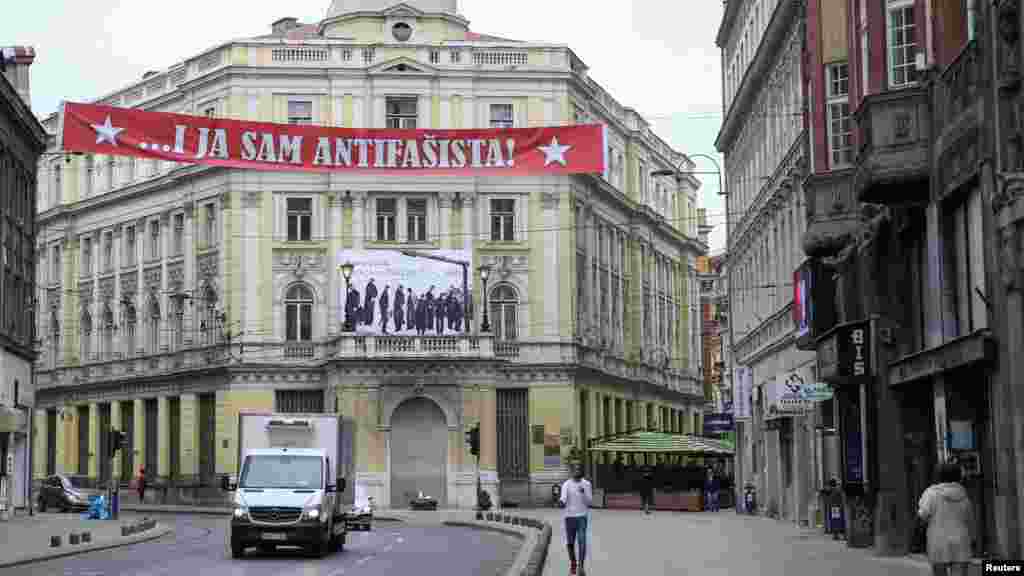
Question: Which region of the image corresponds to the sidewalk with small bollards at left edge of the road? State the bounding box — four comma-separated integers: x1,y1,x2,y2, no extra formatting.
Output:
0,513,171,568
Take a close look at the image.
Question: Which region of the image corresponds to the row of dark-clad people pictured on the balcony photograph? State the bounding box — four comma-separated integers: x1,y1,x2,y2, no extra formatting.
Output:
345,278,466,336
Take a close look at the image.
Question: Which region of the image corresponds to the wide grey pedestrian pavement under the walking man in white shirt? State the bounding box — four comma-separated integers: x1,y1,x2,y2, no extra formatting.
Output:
523,509,930,576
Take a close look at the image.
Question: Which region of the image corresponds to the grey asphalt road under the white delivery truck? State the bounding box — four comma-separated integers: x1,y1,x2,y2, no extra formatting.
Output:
3,515,521,576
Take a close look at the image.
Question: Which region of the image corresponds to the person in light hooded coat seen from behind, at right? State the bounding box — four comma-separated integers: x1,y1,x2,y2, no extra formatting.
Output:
918,462,974,576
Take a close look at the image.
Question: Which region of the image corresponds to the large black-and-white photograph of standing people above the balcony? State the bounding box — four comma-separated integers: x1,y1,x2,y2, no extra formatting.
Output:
337,250,473,336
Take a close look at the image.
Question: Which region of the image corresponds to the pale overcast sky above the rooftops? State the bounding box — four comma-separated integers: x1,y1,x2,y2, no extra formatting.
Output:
6,0,725,252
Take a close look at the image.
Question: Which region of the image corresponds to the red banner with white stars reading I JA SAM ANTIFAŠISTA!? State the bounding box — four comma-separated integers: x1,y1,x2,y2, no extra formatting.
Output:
61,102,606,175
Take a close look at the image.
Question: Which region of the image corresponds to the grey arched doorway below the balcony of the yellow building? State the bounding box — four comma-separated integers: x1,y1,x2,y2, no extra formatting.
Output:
390,397,449,508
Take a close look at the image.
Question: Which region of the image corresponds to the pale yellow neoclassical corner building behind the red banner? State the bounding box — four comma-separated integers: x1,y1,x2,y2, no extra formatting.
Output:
34,0,707,506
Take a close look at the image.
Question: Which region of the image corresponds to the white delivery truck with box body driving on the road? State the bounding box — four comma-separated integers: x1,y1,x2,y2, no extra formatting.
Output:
221,412,347,558
